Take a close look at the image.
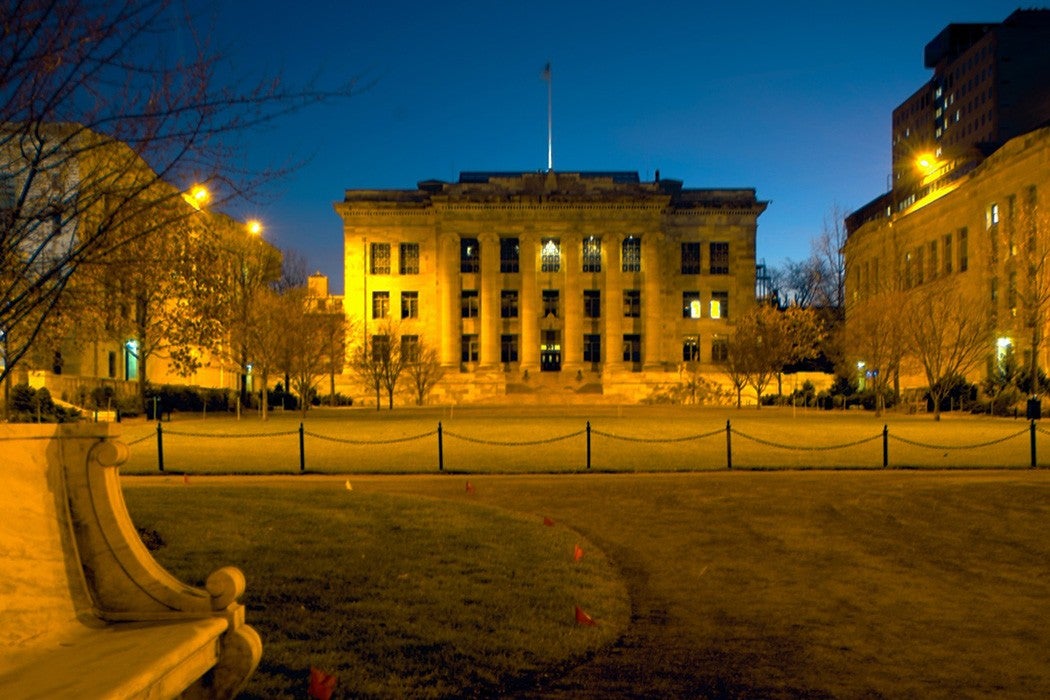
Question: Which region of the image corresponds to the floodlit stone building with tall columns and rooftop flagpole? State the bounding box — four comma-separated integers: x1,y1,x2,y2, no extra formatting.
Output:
335,171,767,401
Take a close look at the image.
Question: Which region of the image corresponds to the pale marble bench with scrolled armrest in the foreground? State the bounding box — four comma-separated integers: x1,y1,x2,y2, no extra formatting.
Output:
0,424,263,699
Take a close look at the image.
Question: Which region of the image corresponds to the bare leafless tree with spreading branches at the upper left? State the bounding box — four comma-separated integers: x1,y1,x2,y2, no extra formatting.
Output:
0,0,350,388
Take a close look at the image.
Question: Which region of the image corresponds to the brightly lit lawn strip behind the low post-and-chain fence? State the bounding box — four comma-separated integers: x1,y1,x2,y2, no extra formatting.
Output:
117,406,1050,473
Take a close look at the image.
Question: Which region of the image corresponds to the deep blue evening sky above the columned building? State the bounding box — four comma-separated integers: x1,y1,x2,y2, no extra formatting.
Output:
211,0,1017,292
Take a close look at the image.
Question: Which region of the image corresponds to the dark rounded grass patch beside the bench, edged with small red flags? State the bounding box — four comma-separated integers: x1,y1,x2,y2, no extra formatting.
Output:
126,478,629,699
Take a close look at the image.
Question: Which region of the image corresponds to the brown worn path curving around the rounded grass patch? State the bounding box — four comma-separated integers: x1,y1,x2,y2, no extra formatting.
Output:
323,470,1050,698
